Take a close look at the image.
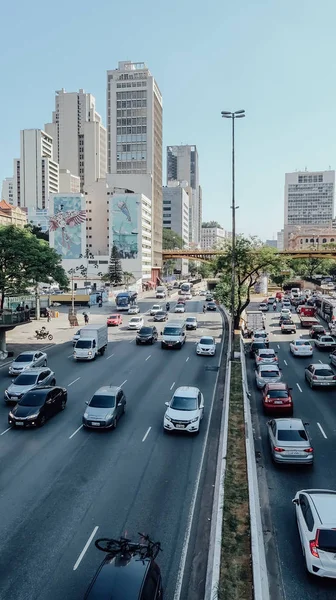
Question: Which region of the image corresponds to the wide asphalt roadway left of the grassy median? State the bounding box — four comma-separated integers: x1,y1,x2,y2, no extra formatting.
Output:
0,299,222,600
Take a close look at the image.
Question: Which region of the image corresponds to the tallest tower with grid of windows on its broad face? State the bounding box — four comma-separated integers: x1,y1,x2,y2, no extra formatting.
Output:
106,61,162,270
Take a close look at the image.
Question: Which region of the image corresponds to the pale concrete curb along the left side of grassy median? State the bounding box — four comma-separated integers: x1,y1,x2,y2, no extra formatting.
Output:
204,307,232,600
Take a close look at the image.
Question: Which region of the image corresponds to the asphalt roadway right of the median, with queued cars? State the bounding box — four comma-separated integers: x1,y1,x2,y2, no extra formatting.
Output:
246,304,336,600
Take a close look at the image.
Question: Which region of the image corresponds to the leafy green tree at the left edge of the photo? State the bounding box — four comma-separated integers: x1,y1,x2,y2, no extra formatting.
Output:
0,225,69,308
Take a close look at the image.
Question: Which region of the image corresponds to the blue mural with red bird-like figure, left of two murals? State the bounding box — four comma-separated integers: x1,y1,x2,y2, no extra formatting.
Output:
49,196,86,258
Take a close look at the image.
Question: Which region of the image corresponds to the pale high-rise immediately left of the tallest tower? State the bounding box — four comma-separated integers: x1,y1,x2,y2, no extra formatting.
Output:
45,89,107,192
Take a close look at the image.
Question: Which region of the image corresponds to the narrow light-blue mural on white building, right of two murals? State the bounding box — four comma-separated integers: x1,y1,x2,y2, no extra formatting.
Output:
112,194,139,258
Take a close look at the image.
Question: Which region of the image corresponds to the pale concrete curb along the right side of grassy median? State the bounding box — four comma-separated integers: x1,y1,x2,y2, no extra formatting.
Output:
240,338,270,600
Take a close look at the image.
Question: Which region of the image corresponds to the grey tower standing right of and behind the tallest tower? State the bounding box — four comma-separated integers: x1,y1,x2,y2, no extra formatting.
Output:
167,145,202,246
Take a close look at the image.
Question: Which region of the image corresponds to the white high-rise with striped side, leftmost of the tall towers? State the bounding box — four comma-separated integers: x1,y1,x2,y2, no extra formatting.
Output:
13,129,59,208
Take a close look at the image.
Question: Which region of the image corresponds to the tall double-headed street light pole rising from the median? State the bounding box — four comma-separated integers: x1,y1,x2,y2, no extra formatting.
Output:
221,110,245,360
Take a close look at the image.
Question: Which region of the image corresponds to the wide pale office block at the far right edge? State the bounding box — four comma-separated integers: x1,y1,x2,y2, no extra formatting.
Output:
284,171,335,248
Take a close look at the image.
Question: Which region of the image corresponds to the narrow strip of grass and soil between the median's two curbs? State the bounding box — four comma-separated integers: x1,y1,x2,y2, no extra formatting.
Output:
218,334,253,600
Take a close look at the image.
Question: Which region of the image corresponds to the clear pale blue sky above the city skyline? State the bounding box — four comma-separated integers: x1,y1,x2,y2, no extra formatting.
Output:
0,0,336,239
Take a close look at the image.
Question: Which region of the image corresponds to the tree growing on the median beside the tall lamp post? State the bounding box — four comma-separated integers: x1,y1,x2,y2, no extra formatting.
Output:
214,236,286,329
